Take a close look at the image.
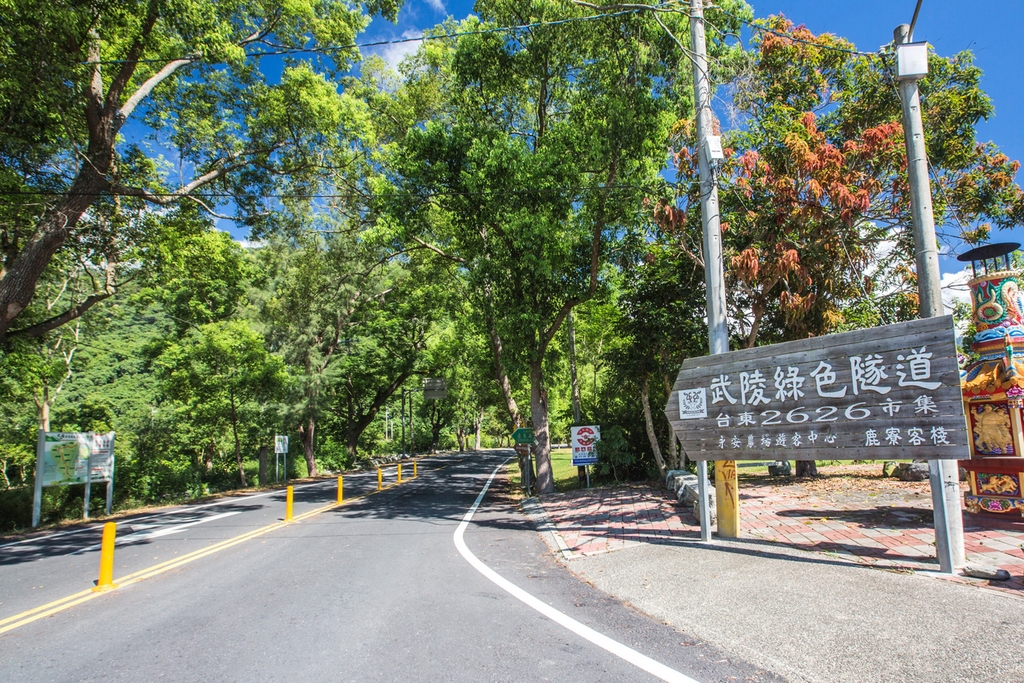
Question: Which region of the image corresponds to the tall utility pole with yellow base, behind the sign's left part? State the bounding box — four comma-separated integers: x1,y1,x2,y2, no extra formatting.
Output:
690,0,739,543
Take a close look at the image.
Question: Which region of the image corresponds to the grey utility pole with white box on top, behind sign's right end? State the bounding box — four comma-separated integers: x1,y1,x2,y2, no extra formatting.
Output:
893,24,966,573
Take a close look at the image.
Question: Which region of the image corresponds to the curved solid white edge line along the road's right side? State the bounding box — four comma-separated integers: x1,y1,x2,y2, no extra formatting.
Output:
455,458,698,683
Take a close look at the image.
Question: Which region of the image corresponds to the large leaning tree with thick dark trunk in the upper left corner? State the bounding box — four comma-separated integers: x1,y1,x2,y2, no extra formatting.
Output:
0,0,399,341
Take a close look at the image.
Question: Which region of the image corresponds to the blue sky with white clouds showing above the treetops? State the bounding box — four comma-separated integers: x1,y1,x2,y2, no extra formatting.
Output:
366,0,1024,301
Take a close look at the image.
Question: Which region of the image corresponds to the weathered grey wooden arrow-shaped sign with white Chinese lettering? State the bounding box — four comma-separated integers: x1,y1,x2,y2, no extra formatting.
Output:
665,315,969,460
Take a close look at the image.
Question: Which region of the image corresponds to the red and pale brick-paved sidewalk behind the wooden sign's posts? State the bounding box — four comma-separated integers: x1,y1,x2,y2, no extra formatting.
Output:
541,483,1024,595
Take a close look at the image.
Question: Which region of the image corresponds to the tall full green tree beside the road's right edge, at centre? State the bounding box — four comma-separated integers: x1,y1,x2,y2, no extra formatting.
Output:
393,0,749,493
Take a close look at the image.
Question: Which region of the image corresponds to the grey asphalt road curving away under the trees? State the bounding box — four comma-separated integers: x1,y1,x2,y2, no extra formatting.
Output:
0,452,778,683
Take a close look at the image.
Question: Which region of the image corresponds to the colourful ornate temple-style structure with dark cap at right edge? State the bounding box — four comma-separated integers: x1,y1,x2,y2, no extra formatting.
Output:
957,243,1024,515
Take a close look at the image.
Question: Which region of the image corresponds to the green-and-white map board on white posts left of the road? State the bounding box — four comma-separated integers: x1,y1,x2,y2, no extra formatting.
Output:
32,430,115,526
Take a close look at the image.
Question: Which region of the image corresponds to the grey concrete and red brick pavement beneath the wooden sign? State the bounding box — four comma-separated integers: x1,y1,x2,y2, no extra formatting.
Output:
542,485,1024,683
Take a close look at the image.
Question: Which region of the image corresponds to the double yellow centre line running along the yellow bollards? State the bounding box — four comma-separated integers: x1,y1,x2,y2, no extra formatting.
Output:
0,468,428,634
